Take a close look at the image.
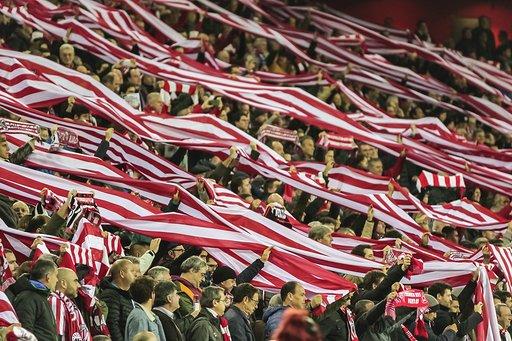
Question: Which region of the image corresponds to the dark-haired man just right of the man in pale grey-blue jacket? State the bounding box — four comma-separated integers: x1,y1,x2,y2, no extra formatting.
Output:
153,281,187,341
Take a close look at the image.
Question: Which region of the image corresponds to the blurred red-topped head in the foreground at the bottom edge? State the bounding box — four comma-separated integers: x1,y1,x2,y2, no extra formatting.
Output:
272,309,323,341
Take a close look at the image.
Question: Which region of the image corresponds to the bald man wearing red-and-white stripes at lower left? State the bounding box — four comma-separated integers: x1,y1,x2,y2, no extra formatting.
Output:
48,268,91,341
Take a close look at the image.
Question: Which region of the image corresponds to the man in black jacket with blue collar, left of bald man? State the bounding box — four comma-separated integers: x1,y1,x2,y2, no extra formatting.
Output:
14,259,58,341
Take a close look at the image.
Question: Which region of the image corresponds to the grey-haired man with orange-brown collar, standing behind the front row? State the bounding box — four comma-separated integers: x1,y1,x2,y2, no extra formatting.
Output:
172,256,208,319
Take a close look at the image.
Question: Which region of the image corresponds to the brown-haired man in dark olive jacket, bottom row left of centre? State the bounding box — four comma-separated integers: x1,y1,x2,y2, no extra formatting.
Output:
187,286,226,341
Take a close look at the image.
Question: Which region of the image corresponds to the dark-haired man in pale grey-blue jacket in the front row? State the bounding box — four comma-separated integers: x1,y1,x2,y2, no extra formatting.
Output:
124,276,166,340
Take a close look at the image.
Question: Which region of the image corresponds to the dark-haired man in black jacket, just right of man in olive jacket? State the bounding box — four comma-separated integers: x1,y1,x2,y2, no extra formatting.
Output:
224,283,259,341
